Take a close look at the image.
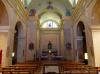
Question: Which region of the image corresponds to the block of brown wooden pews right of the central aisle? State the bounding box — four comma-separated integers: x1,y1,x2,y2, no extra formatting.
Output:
59,61,98,74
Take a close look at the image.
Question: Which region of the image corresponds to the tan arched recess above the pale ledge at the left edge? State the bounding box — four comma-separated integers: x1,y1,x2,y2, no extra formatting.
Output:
0,0,9,26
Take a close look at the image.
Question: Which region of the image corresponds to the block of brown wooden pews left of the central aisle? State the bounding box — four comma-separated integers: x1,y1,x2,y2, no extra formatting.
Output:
0,63,40,74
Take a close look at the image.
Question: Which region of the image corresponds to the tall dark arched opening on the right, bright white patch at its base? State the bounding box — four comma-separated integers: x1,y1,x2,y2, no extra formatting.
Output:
77,21,88,64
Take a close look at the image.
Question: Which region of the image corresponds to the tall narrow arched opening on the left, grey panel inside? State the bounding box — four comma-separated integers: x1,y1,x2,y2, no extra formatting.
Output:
12,21,24,64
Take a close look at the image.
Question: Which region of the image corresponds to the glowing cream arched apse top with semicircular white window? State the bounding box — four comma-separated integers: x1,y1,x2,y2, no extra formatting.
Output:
40,12,61,29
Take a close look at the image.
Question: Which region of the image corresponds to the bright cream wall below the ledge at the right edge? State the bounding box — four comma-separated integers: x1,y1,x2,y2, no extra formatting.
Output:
92,30,100,67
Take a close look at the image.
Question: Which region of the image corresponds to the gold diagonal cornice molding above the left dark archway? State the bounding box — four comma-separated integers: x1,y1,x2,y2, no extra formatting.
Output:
7,0,29,23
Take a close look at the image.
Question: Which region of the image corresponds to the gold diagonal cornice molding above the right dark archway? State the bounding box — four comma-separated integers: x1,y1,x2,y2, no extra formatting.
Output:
72,0,96,23
